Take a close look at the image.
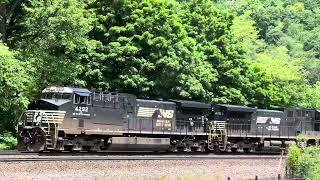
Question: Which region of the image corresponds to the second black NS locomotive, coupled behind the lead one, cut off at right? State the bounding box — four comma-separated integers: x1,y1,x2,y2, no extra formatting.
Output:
213,105,320,152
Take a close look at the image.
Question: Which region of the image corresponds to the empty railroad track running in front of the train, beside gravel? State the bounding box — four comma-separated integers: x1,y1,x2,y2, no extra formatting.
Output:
0,155,281,162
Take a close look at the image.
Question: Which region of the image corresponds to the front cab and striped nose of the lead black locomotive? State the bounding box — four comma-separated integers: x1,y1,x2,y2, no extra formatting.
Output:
17,86,91,152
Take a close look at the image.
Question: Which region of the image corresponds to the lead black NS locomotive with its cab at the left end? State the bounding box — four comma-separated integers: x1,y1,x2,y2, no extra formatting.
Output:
18,87,210,152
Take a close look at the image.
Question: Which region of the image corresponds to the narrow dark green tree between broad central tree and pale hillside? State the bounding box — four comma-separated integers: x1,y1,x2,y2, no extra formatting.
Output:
180,0,258,104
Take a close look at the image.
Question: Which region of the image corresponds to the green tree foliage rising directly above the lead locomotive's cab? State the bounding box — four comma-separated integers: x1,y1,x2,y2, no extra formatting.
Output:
14,0,95,91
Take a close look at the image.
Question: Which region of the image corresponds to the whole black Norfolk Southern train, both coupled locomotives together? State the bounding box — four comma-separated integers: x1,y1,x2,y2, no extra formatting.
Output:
17,86,320,152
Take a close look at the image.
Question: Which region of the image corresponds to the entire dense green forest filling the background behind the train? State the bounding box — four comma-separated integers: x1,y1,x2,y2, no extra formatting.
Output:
0,0,320,132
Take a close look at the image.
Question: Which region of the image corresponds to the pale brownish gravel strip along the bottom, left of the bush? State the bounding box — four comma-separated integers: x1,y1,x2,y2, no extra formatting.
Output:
0,159,284,179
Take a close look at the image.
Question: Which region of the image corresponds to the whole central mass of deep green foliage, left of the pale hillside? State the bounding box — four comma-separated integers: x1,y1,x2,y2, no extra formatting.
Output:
84,0,262,104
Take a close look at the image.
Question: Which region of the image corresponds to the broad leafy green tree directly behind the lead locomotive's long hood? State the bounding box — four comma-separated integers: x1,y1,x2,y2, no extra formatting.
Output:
85,0,216,100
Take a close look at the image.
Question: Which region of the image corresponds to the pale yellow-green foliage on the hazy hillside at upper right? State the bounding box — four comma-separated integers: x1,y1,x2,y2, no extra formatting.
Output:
220,0,320,107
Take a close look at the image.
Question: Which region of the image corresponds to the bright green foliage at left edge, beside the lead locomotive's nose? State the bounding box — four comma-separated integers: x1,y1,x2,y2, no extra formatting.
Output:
0,43,32,132
